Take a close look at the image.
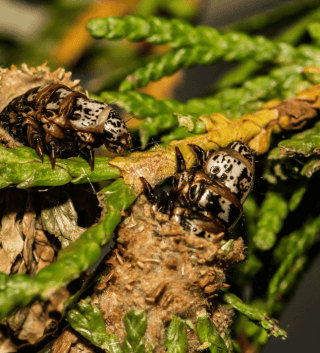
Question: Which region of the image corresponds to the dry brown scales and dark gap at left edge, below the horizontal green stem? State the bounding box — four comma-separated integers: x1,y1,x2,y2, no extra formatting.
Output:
0,189,57,275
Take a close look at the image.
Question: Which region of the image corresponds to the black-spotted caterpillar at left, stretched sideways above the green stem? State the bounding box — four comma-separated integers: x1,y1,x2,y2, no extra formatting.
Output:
0,84,132,170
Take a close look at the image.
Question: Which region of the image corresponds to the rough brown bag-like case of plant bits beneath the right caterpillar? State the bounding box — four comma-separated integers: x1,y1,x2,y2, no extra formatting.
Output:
78,196,245,352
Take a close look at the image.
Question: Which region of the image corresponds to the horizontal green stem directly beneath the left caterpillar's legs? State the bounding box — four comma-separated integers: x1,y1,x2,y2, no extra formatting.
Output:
0,144,120,189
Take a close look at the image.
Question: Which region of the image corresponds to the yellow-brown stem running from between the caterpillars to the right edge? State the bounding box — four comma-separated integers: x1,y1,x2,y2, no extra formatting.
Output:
110,80,320,191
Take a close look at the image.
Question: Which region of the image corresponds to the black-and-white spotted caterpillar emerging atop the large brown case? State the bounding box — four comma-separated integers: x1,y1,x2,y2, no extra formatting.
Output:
141,141,254,241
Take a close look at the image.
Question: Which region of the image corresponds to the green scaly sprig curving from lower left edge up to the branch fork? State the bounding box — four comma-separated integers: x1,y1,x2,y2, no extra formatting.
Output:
0,179,136,320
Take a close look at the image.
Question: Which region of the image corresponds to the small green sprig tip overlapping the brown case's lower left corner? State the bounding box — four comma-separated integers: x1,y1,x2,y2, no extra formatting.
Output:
67,297,123,353
